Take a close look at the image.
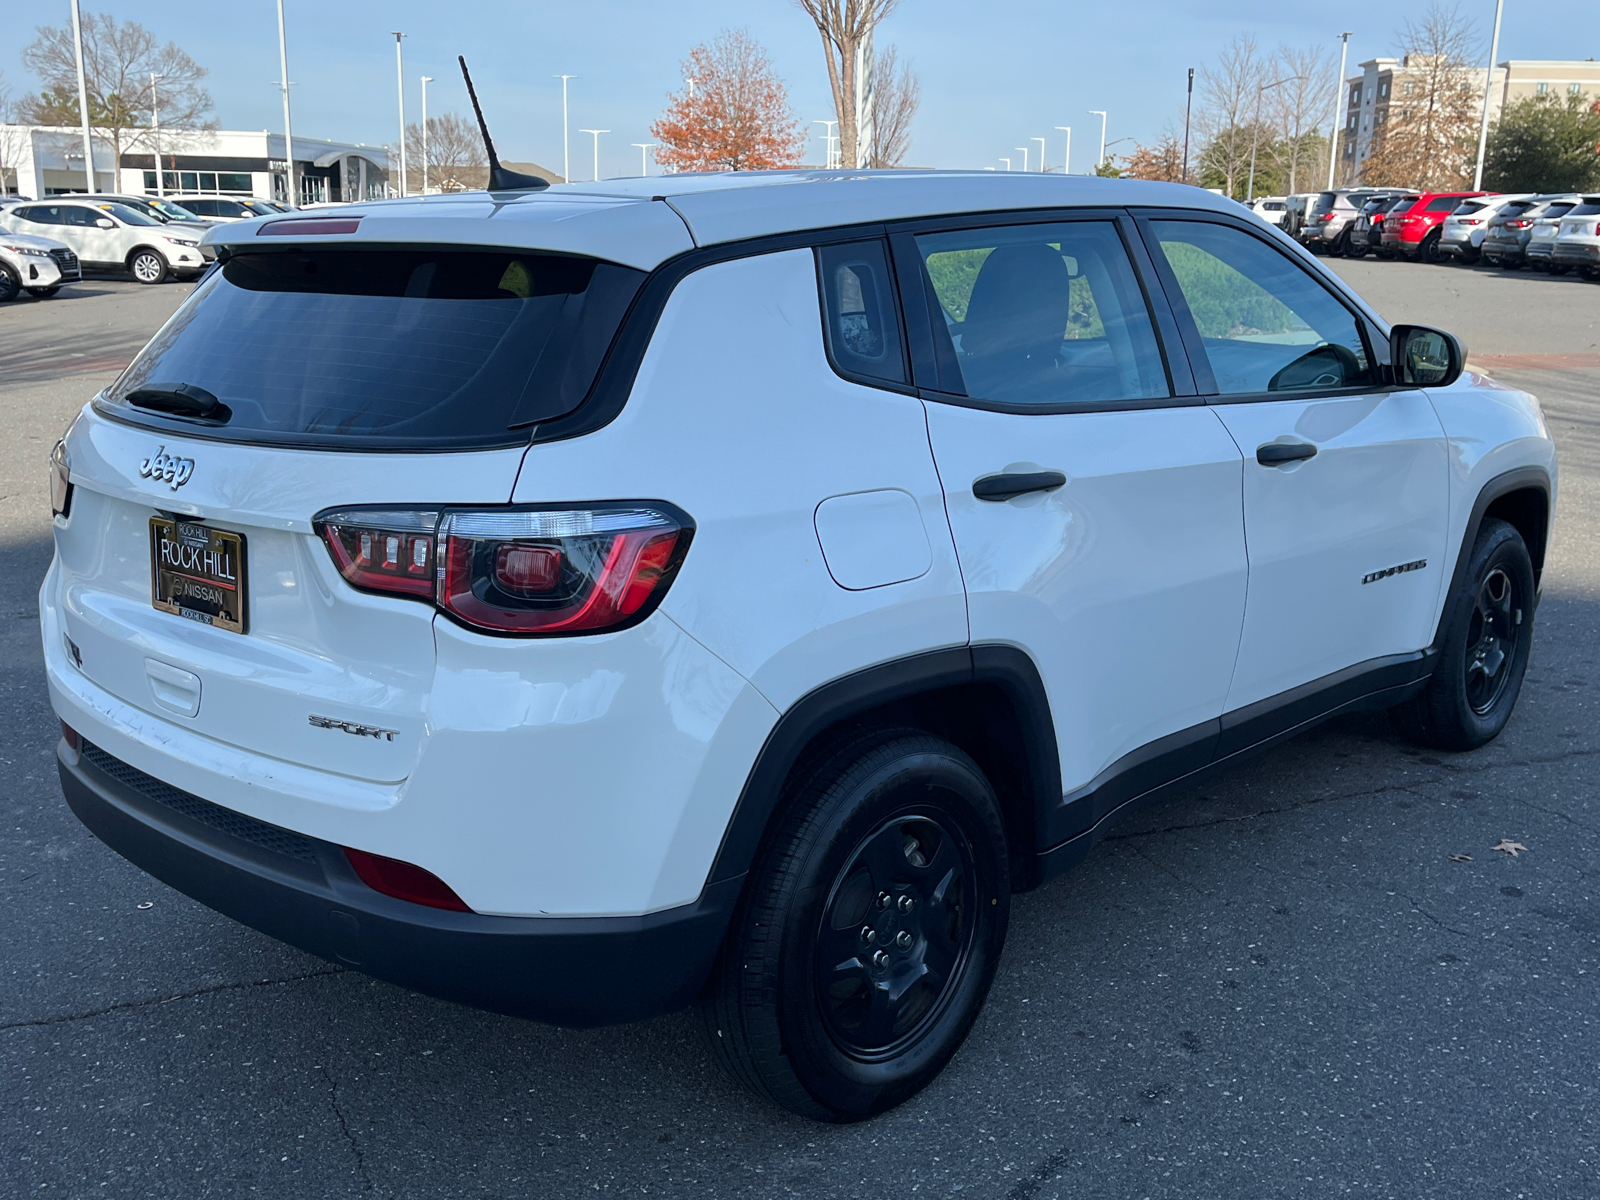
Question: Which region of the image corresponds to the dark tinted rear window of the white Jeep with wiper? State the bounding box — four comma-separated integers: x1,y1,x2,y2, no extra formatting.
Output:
106,248,645,450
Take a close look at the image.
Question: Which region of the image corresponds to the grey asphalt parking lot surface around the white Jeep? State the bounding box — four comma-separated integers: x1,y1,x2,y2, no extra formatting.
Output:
0,261,1600,1200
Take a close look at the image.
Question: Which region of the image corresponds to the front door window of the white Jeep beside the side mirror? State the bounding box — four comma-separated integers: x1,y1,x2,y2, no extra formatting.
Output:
1150,221,1373,395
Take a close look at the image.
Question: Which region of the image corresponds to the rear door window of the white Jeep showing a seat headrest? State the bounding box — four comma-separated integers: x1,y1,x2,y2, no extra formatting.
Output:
917,221,1171,405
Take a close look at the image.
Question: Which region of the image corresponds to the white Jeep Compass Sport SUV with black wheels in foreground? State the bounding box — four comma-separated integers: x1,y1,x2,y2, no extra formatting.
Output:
42,171,1555,1120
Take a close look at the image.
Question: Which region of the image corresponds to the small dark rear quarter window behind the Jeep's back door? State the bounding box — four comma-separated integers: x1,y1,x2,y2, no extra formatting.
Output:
816,240,906,384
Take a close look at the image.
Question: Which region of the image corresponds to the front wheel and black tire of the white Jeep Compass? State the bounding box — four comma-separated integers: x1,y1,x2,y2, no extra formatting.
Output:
1390,518,1533,750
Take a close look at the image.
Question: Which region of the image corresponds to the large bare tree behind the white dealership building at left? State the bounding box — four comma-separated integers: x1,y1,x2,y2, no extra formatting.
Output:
22,13,214,176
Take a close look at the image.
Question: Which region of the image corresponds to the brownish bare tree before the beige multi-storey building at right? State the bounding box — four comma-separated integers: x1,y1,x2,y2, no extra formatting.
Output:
1362,0,1483,190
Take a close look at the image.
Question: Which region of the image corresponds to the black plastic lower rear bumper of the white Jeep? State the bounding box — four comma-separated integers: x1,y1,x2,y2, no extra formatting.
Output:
58,741,742,1026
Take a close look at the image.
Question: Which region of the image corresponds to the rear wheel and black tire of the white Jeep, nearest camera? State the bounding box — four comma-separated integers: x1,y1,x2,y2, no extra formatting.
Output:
699,730,1010,1122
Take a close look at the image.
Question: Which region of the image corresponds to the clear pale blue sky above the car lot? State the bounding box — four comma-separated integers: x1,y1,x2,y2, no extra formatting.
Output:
0,0,1600,179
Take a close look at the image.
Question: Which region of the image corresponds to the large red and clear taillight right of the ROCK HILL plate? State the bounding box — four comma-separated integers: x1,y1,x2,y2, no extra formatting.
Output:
314,501,694,635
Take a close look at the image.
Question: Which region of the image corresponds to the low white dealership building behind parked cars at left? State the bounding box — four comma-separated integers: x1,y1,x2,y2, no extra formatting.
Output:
0,125,389,205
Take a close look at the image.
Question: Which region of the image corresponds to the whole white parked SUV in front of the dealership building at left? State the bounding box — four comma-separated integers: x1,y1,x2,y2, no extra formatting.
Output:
6,197,205,283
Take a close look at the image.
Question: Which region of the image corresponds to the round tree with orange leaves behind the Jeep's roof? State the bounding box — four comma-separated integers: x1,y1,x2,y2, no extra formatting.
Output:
650,29,805,171
